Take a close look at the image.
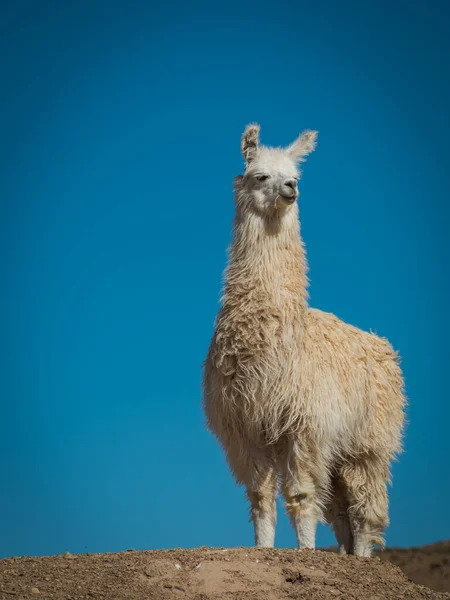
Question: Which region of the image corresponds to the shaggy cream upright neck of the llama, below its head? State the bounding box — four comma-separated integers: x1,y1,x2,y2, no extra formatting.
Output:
224,206,308,322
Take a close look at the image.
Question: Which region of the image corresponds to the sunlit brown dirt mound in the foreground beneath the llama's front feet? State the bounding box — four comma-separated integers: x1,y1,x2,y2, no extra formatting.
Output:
0,548,450,600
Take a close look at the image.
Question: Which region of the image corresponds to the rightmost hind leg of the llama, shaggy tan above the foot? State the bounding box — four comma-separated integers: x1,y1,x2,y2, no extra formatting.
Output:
341,463,389,557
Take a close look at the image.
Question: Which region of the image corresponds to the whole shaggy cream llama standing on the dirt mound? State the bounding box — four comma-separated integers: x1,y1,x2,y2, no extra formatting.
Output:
203,125,405,556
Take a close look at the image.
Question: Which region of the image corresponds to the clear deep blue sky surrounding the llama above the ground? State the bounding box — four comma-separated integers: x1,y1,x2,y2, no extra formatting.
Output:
0,0,450,556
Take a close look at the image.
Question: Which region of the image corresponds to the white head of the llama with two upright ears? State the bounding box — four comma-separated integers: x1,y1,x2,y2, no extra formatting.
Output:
235,125,317,214
